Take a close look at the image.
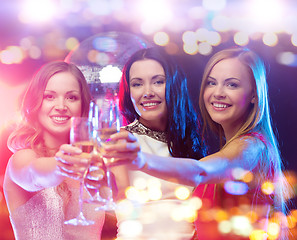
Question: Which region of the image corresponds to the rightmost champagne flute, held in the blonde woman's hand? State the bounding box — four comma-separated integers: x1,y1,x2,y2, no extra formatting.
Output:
96,96,120,211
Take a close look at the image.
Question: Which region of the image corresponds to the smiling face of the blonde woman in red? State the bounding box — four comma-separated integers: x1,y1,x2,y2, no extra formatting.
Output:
203,58,255,136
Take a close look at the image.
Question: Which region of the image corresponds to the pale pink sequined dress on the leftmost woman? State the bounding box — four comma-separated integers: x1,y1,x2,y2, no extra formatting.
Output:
10,183,105,240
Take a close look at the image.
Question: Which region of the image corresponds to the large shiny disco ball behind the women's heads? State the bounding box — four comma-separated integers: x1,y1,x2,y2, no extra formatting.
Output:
65,32,151,97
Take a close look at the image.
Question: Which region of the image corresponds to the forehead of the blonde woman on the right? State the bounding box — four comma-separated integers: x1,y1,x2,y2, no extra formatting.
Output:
209,58,251,79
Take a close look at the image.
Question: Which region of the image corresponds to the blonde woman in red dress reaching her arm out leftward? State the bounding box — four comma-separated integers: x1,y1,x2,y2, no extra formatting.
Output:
106,48,289,240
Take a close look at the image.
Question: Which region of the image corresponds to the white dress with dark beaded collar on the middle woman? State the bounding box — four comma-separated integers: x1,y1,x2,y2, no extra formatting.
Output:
116,121,193,240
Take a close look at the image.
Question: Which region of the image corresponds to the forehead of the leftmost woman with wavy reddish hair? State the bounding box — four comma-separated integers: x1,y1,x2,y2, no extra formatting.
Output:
45,72,80,91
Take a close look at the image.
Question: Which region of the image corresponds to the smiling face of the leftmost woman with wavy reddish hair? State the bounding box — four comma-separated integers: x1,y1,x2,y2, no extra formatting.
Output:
38,72,82,140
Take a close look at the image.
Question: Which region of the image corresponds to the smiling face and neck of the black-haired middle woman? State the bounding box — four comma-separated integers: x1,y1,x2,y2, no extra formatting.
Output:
129,59,167,131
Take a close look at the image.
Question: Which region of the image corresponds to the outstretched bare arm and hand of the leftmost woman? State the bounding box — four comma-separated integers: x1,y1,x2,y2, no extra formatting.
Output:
7,144,88,192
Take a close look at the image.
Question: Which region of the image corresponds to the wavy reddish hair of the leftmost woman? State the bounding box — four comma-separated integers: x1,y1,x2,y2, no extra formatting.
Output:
7,61,91,156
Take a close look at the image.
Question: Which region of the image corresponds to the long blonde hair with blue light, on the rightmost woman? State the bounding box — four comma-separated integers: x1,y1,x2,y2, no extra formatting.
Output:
199,47,288,238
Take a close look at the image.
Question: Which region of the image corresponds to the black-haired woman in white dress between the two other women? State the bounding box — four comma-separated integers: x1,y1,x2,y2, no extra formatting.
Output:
111,48,206,240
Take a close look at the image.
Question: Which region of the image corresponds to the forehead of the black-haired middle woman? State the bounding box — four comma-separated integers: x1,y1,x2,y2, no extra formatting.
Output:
130,59,164,77
